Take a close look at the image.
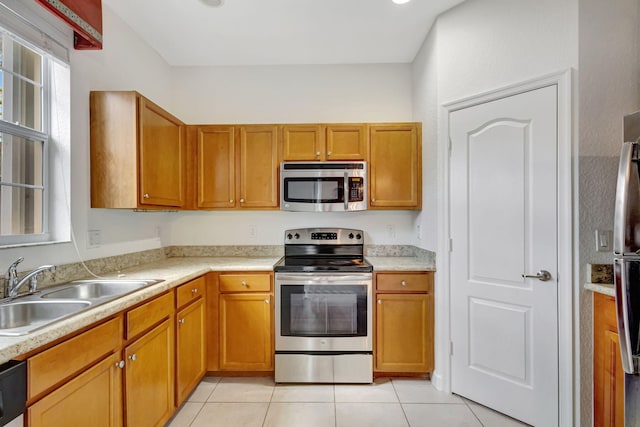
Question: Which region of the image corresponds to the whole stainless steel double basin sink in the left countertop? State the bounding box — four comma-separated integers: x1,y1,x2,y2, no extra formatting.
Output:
0,279,161,336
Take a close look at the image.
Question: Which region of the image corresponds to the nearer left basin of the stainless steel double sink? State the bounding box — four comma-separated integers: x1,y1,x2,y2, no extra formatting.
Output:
0,301,91,336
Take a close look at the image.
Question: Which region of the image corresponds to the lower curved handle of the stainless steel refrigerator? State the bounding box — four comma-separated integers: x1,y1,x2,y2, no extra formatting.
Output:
613,259,635,374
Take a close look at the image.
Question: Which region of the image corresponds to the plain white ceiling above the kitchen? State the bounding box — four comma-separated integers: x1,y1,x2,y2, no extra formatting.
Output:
103,0,464,66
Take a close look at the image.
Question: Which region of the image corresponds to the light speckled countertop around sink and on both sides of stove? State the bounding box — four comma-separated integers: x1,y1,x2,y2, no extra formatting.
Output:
0,257,434,364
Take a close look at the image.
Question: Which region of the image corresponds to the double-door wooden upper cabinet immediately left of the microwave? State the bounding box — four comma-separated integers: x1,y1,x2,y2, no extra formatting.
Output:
191,125,279,209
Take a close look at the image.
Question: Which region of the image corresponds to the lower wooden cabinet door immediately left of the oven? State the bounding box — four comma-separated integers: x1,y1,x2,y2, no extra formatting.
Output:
219,293,273,371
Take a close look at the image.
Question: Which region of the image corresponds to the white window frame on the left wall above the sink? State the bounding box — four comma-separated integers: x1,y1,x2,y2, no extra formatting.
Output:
0,0,73,248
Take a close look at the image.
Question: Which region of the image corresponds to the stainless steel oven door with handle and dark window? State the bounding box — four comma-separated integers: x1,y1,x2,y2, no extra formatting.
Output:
275,273,373,353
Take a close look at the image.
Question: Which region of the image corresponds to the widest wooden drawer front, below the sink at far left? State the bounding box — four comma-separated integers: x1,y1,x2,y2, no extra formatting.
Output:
27,317,122,399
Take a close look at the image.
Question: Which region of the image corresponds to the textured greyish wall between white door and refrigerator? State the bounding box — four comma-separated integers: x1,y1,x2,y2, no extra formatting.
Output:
579,0,640,425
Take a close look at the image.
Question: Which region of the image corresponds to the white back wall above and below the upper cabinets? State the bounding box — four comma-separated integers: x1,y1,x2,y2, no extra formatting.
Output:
169,64,418,245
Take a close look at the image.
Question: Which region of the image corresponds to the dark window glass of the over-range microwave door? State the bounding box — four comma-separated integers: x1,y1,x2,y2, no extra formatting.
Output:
284,178,344,203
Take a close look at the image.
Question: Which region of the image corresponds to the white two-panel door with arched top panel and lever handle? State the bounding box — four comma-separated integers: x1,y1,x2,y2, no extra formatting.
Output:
449,85,559,427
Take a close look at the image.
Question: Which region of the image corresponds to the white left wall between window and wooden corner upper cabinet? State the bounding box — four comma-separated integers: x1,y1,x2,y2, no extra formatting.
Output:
0,5,172,270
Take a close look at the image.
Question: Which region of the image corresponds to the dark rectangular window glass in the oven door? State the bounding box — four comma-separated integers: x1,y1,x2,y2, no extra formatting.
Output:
280,285,367,337
